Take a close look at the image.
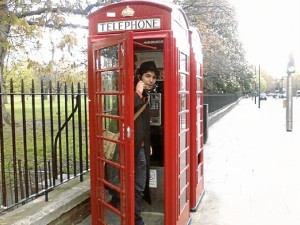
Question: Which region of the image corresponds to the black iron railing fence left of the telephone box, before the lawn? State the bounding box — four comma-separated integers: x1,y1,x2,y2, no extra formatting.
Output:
0,81,89,212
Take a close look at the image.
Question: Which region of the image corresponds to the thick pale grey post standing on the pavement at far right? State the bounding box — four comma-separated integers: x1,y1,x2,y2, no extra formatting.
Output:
286,54,295,131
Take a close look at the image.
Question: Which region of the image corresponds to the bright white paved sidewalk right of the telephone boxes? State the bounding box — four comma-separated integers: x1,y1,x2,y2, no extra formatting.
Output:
191,98,300,225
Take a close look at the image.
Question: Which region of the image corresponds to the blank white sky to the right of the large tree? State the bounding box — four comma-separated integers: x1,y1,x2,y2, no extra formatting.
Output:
229,0,300,78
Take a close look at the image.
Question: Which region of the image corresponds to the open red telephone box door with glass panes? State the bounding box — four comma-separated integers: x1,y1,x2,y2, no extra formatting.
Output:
88,32,134,225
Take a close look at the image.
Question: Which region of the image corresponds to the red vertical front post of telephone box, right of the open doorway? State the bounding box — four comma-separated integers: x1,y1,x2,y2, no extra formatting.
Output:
164,34,179,224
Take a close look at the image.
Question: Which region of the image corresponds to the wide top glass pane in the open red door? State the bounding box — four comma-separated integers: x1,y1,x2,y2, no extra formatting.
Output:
100,46,119,69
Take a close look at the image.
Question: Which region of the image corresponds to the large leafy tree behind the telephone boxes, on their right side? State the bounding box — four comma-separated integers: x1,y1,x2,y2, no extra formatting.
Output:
182,0,253,93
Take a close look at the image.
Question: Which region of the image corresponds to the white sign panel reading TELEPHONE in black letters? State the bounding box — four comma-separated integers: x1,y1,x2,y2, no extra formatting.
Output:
98,18,161,33
